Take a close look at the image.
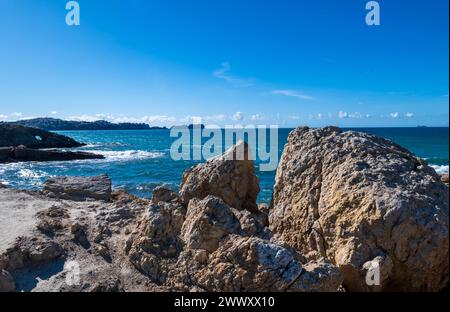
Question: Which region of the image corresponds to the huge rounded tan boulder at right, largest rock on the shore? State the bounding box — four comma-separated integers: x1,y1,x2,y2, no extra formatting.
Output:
270,127,449,291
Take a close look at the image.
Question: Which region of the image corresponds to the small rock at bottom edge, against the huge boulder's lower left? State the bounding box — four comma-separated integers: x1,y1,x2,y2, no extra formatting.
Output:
289,260,343,292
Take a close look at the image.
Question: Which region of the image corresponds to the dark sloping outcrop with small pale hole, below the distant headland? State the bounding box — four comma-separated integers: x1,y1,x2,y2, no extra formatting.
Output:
0,123,84,148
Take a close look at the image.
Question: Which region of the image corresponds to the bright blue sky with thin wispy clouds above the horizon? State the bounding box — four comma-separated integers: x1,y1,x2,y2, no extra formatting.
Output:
0,0,449,127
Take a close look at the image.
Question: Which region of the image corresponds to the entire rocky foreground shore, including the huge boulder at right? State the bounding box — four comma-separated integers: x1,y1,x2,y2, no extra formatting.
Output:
0,127,449,292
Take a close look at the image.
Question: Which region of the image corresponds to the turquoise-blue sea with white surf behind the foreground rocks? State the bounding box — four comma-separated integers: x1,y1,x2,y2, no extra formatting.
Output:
0,128,449,202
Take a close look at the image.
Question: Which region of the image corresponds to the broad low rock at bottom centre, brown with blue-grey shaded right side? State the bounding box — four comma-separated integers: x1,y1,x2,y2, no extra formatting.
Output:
195,235,302,292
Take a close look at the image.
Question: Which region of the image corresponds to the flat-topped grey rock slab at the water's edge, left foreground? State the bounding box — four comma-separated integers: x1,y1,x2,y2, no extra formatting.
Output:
43,174,111,201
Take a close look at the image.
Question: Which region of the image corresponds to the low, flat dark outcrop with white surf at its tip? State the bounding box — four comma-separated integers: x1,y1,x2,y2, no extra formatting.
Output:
0,145,105,163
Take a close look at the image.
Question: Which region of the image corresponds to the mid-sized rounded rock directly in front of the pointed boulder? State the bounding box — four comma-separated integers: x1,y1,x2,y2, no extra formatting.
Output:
181,196,240,252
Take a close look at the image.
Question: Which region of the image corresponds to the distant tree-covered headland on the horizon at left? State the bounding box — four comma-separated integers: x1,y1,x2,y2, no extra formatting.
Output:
2,118,167,131
